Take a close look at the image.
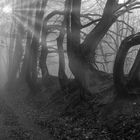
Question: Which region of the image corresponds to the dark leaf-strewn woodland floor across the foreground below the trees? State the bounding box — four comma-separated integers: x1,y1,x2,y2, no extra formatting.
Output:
0,80,140,140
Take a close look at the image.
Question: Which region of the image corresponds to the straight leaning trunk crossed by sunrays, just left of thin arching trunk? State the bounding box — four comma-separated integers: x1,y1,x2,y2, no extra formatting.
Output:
31,0,47,91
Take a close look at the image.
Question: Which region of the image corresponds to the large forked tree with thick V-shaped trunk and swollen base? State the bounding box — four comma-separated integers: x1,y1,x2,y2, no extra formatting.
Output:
67,0,116,94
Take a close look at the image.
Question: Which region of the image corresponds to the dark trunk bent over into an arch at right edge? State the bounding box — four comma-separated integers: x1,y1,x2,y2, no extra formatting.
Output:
113,33,140,96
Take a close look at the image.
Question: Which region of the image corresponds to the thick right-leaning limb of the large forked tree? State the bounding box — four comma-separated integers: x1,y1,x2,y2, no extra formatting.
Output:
81,0,116,61
